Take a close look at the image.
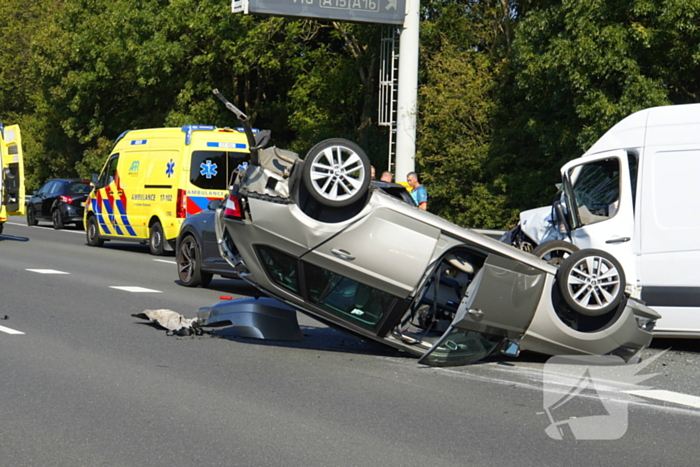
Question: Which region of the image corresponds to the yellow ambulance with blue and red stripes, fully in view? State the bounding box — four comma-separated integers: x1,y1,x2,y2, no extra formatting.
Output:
84,125,249,255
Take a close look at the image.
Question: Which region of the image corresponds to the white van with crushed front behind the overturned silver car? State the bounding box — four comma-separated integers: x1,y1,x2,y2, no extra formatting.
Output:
504,104,700,337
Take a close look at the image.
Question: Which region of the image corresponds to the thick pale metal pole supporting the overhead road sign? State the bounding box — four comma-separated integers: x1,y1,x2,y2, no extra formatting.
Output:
395,0,420,181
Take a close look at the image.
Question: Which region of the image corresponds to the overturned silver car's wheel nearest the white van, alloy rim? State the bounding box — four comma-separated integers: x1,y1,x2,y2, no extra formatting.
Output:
557,249,625,316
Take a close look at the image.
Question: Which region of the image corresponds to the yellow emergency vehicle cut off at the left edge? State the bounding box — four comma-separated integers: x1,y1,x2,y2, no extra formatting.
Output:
0,123,24,234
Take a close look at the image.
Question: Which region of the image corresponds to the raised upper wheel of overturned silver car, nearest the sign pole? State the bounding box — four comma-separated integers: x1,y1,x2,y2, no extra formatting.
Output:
302,138,370,207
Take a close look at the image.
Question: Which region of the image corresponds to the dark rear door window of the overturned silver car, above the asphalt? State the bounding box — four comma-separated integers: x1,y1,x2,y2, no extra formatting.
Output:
304,263,395,330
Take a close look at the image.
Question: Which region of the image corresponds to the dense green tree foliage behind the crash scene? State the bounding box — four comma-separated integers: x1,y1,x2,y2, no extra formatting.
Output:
0,0,700,228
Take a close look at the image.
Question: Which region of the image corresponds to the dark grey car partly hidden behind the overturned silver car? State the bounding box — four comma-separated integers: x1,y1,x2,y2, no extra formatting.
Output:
175,180,416,287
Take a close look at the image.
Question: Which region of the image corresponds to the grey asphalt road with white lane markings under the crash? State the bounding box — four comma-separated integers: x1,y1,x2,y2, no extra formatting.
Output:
0,218,700,467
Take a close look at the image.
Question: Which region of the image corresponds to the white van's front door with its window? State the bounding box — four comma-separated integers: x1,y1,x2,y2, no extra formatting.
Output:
562,150,638,283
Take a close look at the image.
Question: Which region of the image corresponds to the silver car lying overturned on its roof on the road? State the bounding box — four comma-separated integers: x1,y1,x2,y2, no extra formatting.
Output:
211,91,659,366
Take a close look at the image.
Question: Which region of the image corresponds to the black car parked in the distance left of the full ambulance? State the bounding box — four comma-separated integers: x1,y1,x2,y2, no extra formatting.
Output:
27,178,92,230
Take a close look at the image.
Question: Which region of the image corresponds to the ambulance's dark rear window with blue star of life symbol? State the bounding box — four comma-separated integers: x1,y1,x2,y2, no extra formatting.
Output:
190,151,248,190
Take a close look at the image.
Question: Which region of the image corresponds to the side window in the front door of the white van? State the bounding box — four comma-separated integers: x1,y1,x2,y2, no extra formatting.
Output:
569,158,620,225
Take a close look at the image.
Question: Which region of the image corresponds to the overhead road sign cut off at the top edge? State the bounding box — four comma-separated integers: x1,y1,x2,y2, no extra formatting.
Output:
231,0,406,26
